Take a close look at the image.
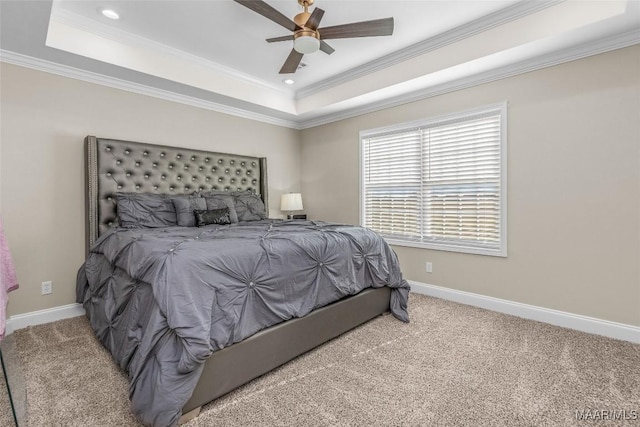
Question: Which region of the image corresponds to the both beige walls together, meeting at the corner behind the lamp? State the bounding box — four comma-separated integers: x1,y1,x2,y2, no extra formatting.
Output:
0,46,640,325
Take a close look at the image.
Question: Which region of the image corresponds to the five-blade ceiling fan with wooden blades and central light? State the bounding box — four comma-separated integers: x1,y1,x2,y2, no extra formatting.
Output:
234,0,393,74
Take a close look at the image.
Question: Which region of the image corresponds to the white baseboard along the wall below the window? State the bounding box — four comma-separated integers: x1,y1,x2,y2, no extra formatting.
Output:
409,281,640,344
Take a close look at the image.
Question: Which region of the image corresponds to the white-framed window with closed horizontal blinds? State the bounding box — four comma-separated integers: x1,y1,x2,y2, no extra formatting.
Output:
360,104,507,256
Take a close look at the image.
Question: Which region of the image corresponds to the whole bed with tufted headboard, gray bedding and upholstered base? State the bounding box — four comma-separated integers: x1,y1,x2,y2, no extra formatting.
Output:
77,136,409,426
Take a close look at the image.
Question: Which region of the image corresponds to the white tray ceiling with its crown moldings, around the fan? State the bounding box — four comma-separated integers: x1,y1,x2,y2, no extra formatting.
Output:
0,0,640,128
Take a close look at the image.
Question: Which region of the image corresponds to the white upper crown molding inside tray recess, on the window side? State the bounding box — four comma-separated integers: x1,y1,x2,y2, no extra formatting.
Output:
295,0,566,100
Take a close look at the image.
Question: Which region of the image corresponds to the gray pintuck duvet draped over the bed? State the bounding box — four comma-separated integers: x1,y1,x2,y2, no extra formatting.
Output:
77,221,409,426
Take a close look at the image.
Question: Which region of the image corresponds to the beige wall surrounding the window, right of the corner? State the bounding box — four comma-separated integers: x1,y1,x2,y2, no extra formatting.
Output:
302,46,640,325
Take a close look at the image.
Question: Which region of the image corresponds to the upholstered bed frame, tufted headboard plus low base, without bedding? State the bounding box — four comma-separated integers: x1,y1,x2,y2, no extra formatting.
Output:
85,136,391,422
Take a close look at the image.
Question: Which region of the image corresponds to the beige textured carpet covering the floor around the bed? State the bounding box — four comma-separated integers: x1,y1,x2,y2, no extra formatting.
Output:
1,294,640,427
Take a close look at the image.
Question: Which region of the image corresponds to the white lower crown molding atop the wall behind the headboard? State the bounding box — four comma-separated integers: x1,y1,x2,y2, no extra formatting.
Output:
0,49,299,129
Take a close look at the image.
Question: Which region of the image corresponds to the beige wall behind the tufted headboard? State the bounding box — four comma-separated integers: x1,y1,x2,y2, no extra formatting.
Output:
0,63,300,315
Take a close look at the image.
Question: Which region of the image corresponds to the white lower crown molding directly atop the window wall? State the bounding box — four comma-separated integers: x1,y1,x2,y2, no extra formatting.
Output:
297,29,640,129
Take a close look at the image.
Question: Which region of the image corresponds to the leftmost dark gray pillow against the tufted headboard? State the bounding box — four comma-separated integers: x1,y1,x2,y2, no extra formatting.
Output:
115,193,177,228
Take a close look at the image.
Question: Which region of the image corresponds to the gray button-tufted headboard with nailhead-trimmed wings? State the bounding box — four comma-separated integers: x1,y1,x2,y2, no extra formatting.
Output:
85,136,269,252
